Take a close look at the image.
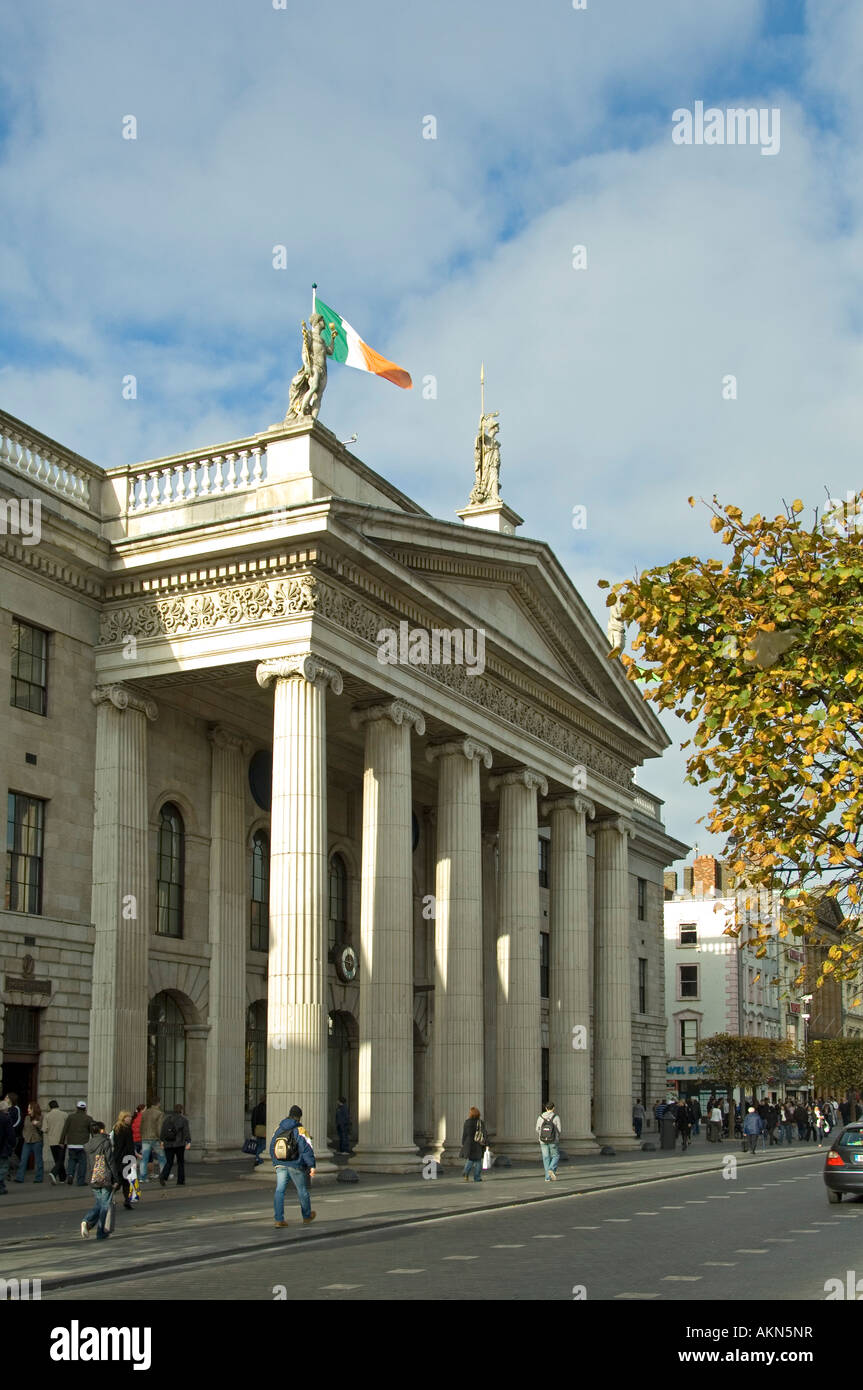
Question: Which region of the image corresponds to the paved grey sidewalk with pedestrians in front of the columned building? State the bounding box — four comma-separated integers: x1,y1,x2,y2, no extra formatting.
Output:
0,1131,827,1298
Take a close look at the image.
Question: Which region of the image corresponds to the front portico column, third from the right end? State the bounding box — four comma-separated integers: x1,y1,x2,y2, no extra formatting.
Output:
489,767,549,1158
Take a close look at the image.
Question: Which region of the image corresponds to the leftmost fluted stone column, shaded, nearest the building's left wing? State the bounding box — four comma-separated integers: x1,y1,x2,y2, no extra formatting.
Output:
86,685,158,1125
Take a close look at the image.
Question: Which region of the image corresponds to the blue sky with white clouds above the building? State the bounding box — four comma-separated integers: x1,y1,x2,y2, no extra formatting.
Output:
0,0,863,852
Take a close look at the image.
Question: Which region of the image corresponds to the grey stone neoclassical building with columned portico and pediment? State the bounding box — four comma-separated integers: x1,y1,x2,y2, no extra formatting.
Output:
0,414,687,1170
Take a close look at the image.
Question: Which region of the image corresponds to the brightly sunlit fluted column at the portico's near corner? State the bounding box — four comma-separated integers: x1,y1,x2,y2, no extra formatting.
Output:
256,655,342,1158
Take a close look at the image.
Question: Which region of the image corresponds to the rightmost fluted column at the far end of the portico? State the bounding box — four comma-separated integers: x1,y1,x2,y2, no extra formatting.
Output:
592,816,639,1150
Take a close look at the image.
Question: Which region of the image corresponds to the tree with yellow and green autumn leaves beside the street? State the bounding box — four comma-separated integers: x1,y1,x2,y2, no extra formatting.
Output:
599,492,863,983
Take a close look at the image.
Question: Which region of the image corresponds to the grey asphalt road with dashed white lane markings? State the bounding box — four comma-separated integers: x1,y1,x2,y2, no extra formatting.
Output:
43,1152,863,1295
